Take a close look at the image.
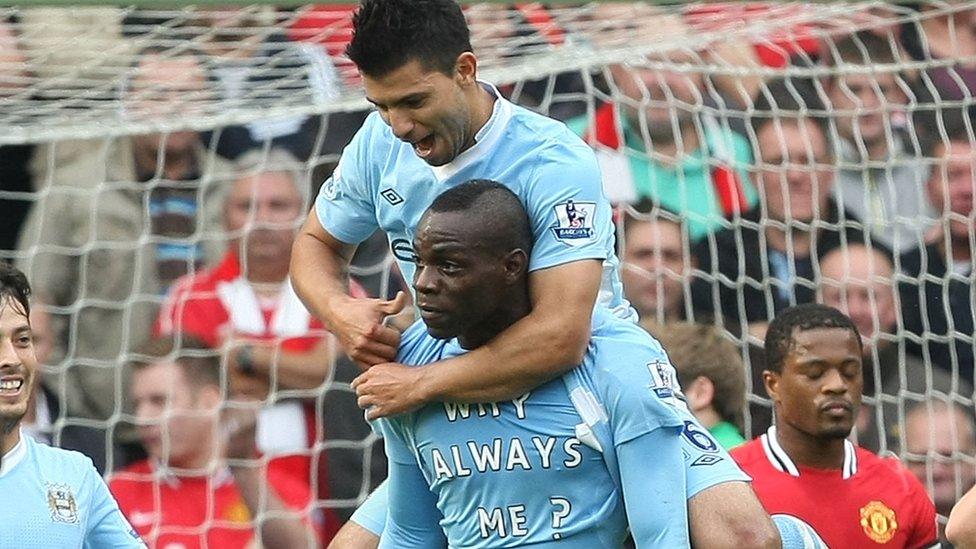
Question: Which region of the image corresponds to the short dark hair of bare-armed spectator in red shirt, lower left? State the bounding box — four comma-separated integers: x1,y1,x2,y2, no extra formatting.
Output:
128,334,222,389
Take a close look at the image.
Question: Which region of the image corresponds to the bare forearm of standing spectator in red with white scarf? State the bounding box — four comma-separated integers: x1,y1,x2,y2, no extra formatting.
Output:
254,336,335,389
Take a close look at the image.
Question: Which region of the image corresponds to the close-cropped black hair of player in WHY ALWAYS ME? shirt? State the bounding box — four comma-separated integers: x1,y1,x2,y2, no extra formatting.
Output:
424,179,533,254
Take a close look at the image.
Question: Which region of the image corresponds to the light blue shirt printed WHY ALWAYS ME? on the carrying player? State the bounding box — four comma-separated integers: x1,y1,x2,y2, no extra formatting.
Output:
374,311,716,548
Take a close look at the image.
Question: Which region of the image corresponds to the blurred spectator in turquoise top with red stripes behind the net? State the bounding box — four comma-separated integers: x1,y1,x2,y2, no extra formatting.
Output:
568,14,757,233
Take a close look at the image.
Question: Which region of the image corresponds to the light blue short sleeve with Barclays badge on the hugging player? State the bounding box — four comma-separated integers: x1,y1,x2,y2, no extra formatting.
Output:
522,139,614,271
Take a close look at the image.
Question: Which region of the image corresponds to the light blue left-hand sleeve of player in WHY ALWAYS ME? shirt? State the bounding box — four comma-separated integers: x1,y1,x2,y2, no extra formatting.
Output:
380,416,447,549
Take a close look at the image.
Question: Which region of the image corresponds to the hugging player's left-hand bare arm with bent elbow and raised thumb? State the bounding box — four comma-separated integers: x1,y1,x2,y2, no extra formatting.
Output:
289,210,406,366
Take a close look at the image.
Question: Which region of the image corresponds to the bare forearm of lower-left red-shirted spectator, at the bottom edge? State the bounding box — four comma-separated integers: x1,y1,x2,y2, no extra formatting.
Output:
231,465,316,548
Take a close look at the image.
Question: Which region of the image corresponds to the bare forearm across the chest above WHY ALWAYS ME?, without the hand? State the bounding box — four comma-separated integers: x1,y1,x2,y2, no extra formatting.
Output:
421,308,590,402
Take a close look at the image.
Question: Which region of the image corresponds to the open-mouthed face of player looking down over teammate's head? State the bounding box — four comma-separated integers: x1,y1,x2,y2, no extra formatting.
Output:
363,58,477,166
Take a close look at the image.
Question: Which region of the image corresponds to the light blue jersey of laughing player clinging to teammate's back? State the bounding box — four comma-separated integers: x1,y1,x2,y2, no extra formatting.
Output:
315,84,637,320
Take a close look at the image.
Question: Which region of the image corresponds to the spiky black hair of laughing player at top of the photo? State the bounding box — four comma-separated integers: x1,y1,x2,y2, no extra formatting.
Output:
346,0,472,77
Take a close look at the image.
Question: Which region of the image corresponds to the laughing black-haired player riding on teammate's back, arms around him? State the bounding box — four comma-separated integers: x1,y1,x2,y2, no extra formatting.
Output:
291,0,775,547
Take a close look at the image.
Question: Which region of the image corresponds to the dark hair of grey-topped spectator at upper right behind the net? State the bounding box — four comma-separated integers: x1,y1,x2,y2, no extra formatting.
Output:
749,76,833,151
